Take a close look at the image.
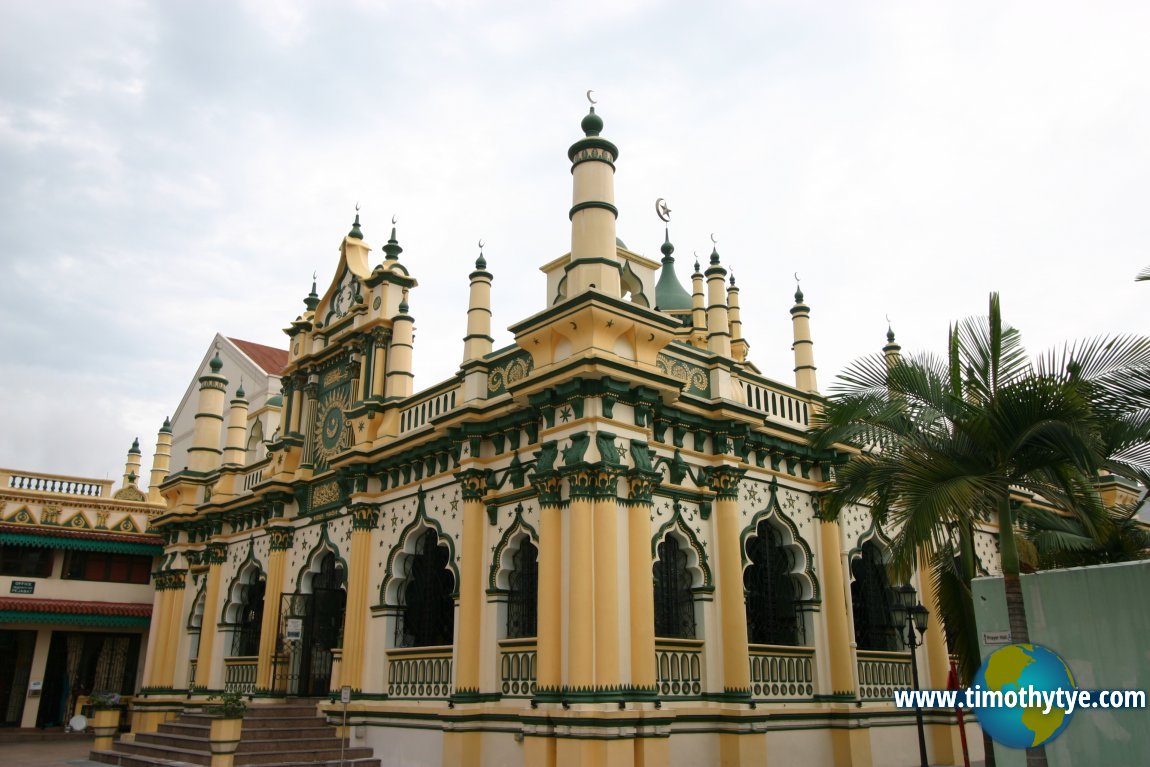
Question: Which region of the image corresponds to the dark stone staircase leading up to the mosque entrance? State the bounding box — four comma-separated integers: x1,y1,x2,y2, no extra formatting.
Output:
91,703,380,767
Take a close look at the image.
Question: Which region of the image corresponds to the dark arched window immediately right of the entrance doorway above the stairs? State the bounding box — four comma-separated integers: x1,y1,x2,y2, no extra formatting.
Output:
396,529,455,647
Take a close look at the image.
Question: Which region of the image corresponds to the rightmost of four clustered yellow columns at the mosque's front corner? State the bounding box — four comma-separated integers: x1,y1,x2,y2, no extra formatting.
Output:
626,471,662,694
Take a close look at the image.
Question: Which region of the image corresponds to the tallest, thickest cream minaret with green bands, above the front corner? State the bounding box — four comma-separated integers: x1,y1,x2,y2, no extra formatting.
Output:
567,96,622,298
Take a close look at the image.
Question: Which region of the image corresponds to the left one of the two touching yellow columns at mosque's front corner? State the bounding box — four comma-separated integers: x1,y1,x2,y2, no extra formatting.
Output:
566,469,598,691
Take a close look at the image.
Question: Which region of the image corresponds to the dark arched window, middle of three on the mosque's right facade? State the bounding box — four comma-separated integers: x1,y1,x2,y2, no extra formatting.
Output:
743,520,805,645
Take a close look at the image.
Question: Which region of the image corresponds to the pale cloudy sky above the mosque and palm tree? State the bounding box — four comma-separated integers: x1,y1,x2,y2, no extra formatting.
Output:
0,0,1150,478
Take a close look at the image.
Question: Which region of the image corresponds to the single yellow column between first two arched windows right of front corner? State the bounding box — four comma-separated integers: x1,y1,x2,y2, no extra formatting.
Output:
711,466,751,696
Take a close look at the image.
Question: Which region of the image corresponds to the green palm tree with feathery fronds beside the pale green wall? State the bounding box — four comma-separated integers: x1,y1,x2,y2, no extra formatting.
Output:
812,293,1150,765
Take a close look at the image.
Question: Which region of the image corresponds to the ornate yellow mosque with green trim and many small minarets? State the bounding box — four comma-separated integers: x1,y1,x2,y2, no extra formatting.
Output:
116,107,996,767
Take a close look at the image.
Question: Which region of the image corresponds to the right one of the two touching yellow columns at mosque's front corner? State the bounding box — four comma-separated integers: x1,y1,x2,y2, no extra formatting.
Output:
593,467,621,690
